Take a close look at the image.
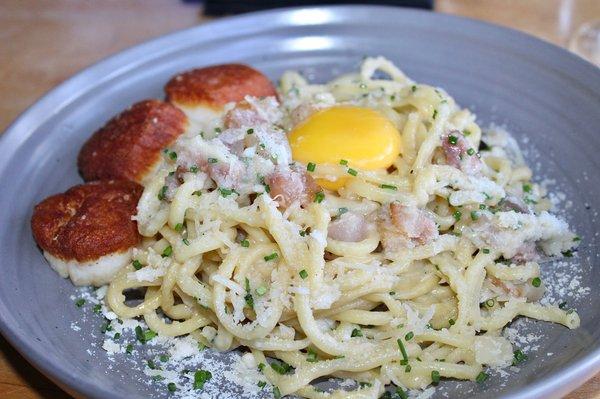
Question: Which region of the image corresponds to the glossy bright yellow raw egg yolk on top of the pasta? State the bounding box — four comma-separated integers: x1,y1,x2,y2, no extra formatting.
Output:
288,106,401,190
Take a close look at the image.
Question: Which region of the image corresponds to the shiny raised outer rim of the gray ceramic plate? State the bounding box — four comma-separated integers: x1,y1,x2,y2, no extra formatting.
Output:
0,5,600,399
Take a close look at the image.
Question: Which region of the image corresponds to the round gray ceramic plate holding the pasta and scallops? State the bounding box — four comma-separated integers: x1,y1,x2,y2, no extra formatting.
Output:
0,6,600,398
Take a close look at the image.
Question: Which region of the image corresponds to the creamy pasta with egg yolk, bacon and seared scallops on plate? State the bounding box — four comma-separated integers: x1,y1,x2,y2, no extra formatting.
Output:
32,57,580,398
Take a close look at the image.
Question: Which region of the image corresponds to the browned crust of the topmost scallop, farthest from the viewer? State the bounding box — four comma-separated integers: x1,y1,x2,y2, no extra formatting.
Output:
165,64,276,109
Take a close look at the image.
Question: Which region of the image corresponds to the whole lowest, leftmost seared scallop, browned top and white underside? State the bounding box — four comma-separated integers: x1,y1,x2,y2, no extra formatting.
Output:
31,180,142,286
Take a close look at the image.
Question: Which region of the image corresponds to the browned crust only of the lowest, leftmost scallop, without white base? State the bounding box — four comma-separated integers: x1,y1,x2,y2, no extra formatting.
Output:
31,180,142,262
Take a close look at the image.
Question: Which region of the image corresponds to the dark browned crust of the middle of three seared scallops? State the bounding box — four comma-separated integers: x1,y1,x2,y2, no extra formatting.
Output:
77,100,188,183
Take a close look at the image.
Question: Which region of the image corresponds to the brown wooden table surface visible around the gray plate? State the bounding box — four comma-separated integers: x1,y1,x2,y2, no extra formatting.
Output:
0,0,600,399
